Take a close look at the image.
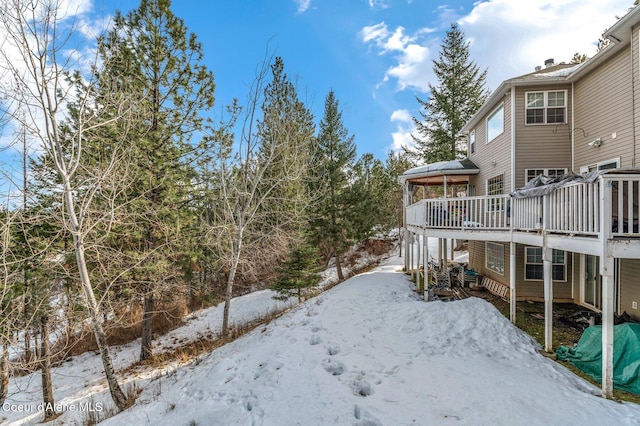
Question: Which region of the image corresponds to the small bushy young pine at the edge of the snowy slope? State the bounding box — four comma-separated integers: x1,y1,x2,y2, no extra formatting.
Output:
271,241,320,302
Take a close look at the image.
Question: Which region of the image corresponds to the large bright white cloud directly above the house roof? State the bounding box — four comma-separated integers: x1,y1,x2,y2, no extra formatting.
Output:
458,0,632,89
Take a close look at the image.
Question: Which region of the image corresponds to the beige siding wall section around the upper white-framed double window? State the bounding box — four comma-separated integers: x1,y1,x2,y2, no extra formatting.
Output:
514,84,572,188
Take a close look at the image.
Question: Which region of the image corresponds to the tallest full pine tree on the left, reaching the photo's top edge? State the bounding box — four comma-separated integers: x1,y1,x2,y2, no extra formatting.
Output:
96,0,215,360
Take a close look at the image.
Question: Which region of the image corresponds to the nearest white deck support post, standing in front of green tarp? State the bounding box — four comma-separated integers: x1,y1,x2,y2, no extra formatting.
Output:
600,256,615,398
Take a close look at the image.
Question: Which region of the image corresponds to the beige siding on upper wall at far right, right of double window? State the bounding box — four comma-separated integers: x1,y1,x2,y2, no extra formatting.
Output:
574,49,634,171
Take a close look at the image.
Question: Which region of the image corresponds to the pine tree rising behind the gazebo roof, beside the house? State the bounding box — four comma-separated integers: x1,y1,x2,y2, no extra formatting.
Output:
409,23,488,163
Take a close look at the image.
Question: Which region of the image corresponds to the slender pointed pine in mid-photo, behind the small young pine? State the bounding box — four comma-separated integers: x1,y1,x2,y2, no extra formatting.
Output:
312,90,356,280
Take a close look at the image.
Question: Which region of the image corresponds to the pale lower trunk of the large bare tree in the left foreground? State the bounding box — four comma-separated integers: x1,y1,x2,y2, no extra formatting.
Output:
60,185,129,410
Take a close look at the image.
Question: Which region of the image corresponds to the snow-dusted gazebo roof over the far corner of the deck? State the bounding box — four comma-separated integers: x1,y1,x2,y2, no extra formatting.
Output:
398,158,480,186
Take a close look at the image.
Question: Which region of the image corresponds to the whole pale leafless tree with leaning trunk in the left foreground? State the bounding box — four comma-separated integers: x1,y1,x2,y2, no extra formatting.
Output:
0,0,129,409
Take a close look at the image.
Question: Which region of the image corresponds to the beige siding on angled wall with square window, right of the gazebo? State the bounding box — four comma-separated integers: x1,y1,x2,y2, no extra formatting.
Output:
469,96,511,195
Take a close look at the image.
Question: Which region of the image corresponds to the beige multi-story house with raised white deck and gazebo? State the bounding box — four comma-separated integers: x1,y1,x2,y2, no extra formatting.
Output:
399,7,640,397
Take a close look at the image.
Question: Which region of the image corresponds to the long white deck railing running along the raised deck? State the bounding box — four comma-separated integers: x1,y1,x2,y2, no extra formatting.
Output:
406,174,640,238
